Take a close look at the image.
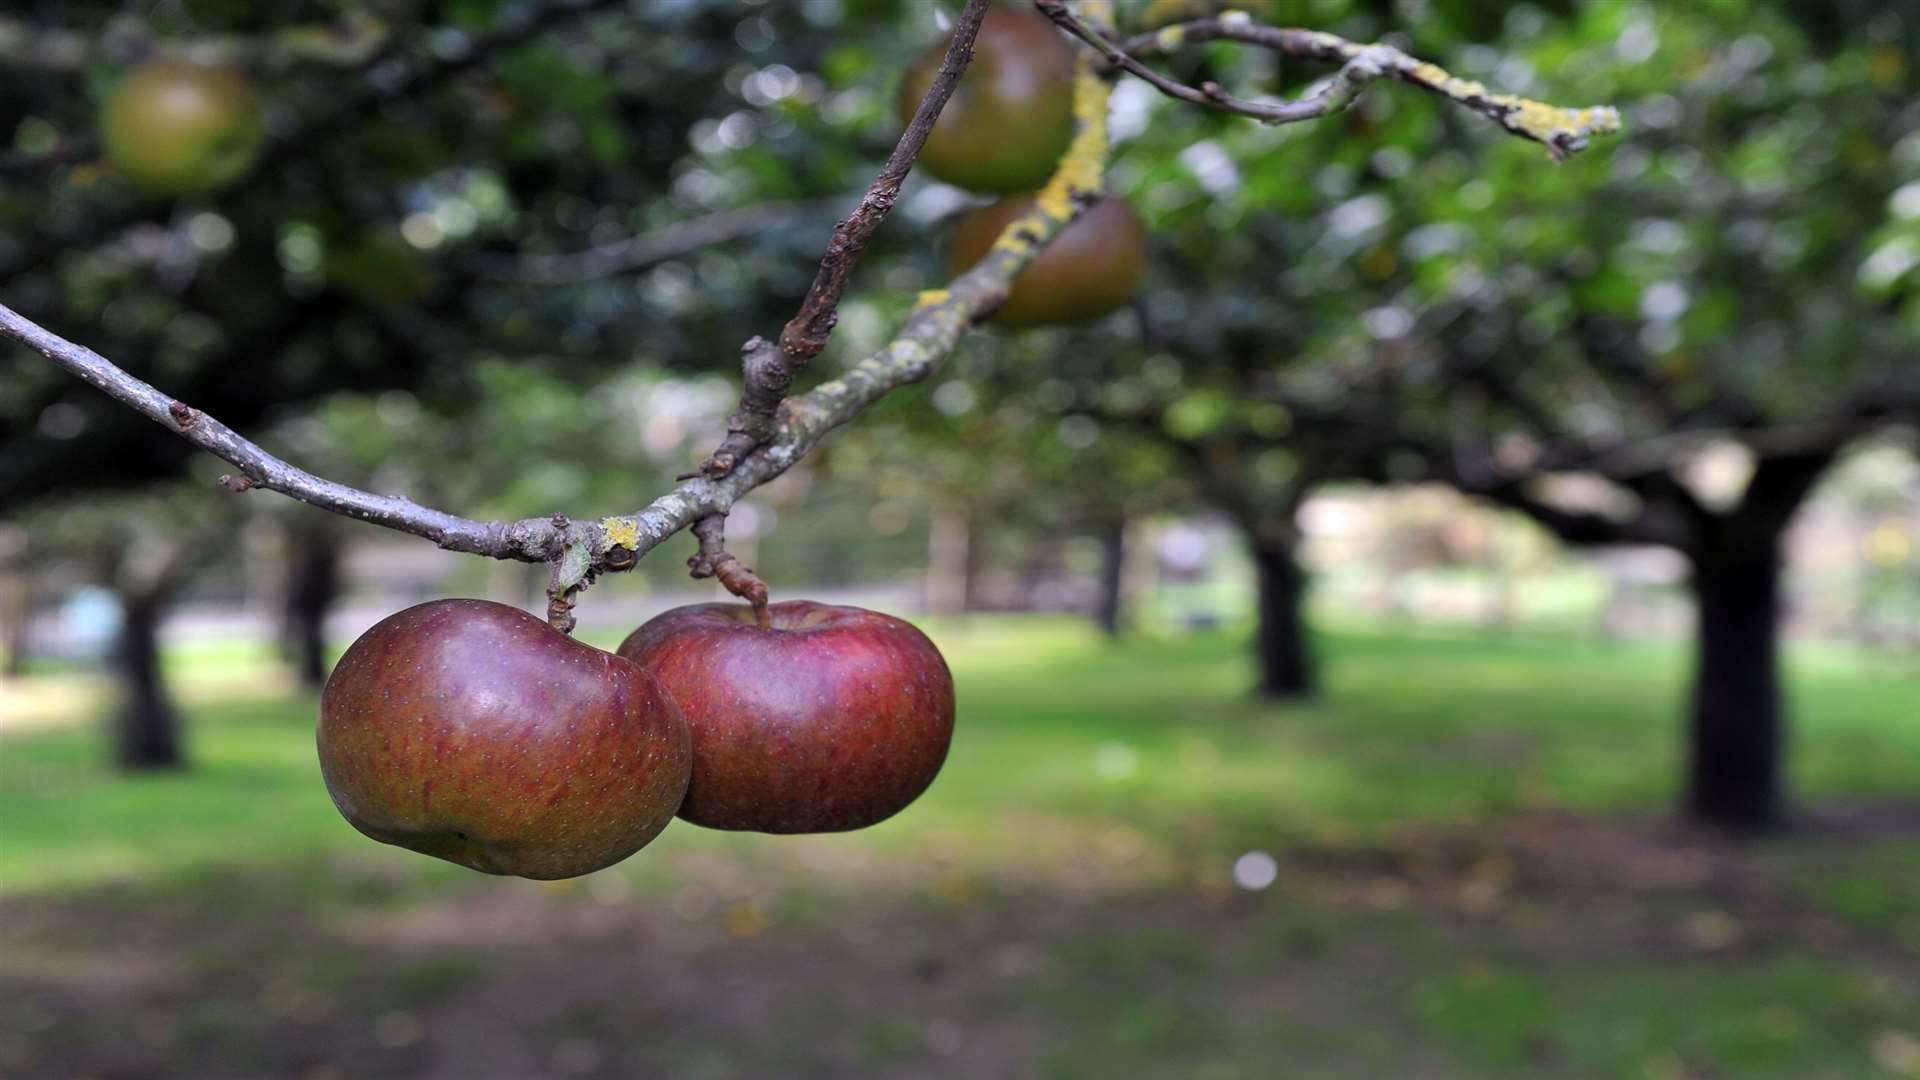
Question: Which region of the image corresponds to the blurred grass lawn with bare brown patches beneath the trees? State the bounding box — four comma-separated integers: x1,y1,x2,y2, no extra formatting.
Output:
0,619,1920,1080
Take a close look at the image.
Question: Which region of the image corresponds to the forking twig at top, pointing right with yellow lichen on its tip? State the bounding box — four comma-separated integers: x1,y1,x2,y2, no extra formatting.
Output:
1033,0,1620,161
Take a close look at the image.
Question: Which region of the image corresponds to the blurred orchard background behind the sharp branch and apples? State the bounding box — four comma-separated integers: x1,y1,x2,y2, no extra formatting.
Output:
0,0,1920,1078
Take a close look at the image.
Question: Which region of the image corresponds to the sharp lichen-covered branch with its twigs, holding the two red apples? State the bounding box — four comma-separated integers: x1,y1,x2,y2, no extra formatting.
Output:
0,0,1619,625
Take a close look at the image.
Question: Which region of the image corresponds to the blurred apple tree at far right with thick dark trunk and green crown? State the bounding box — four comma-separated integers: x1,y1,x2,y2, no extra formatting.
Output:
1269,4,1920,832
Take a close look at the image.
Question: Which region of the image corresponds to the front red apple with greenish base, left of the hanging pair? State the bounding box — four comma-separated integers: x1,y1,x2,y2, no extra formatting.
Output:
319,600,691,878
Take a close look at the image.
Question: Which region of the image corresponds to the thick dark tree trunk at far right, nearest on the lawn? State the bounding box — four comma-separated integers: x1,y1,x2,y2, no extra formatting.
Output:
1686,544,1784,834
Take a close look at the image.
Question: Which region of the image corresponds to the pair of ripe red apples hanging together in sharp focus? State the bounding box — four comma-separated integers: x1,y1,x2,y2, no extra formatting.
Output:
319,600,954,878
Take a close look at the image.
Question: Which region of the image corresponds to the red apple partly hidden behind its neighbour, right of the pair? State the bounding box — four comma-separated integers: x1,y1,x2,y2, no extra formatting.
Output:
620,600,954,832
